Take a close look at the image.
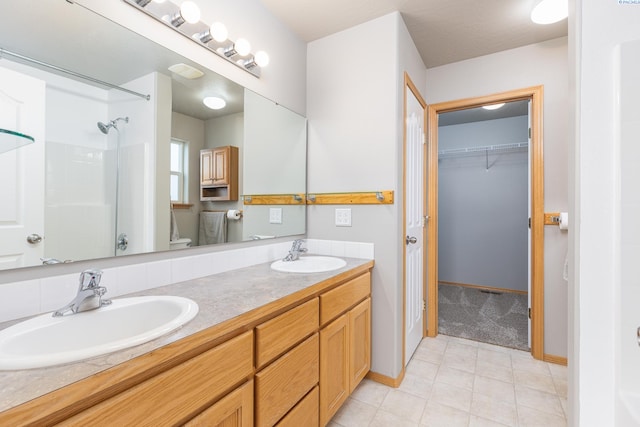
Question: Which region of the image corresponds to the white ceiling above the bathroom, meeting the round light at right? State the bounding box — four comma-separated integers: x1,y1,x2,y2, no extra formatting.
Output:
260,0,567,68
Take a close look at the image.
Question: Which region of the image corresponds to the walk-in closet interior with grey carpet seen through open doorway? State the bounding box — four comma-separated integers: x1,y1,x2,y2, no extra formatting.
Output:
438,100,530,350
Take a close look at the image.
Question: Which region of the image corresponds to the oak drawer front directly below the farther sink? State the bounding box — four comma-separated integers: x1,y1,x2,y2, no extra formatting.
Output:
320,272,371,325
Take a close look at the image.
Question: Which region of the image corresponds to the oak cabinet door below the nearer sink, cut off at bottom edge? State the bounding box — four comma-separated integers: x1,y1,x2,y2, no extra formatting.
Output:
185,380,253,427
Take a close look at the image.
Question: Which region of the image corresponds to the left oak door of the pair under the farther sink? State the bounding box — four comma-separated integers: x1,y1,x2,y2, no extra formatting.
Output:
320,313,349,426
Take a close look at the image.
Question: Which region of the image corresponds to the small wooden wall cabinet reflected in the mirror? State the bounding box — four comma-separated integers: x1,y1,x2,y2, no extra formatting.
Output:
200,145,238,201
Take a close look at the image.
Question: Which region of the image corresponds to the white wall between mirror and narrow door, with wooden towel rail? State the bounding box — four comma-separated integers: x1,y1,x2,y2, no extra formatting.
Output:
307,13,425,378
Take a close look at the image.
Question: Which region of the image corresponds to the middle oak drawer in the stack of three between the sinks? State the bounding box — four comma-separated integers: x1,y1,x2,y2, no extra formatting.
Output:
255,333,320,427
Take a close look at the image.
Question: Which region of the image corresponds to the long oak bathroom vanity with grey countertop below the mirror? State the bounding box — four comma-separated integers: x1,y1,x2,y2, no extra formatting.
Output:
0,259,373,426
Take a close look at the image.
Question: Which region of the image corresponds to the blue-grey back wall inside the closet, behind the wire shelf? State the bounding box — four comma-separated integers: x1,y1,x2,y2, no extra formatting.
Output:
438,116,528,292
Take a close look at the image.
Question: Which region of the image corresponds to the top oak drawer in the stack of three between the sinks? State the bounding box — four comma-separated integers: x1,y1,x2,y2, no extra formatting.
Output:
256,298,320,369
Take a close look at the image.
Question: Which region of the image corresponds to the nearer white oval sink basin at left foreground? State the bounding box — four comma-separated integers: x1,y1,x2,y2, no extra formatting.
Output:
0,296,198,370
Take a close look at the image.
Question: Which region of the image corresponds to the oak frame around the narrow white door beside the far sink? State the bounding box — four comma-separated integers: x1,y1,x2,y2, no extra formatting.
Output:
401,71,429,370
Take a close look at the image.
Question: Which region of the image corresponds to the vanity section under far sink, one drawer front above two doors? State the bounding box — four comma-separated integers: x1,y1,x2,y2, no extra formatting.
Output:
320,273,371,426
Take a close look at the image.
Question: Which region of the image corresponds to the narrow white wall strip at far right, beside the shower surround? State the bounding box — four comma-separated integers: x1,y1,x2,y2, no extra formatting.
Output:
569,0,640,426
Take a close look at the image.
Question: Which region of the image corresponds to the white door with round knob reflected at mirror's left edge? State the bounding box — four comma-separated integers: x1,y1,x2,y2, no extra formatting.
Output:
0,67,45,270
